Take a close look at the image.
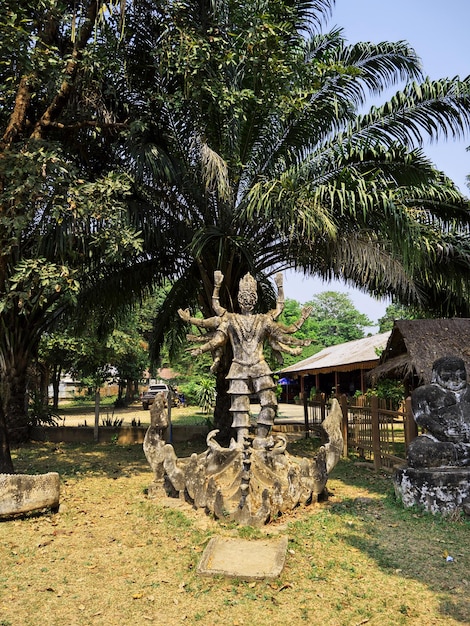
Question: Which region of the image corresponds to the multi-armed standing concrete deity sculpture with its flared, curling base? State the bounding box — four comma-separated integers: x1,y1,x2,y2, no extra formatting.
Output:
144,272,343,526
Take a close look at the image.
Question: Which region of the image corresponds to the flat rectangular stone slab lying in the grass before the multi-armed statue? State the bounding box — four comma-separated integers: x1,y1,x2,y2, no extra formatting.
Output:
197,537,287,580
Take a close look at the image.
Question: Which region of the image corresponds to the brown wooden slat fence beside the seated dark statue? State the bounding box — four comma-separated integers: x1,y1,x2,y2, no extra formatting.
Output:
304,395,418,469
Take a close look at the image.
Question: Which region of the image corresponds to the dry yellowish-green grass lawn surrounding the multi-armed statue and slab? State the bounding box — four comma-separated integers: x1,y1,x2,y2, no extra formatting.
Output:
0,440,470,626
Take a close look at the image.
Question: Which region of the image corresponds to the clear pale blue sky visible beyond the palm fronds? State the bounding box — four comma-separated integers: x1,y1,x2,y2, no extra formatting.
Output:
284,0,470,321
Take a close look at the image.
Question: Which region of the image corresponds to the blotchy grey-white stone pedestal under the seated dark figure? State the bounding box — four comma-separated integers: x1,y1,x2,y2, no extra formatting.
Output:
393,467,470,515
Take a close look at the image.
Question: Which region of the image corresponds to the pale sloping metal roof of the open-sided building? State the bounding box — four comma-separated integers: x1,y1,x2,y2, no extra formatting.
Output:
279,331,390,376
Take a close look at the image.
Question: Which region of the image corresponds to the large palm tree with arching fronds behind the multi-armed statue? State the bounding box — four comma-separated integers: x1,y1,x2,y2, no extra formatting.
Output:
114,0,470,434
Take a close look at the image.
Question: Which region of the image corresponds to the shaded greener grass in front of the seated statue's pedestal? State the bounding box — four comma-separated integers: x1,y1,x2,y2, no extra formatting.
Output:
289,439,470,624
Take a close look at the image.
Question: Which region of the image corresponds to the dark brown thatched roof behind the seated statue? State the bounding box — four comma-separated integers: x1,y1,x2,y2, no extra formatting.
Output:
369,318,470,384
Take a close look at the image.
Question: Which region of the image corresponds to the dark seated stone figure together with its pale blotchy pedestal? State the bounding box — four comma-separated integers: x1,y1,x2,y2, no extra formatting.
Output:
395,356,470,513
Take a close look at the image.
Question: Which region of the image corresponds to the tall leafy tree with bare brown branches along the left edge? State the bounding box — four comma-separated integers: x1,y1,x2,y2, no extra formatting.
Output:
0,0,152,464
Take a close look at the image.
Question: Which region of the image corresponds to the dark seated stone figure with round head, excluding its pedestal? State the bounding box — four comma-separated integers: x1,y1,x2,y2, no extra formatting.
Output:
408,356,470,468
